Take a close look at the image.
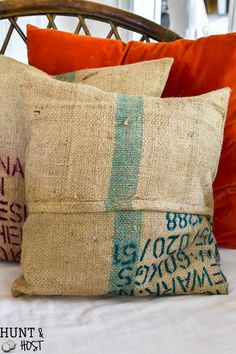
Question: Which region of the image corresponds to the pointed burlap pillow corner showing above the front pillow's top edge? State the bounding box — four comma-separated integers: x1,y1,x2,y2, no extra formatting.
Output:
55,58,174,97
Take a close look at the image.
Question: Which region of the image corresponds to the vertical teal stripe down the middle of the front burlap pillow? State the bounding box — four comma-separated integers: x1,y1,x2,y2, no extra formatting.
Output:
105,95,143,295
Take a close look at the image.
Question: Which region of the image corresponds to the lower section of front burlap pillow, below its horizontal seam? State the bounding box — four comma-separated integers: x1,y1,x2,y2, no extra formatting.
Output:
13,211,227,296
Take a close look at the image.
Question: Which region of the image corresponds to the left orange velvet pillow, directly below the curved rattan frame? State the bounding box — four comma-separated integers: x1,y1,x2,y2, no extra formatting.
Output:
27,25,125,75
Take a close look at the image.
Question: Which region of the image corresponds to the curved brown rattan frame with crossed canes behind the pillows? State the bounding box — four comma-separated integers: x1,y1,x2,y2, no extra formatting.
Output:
0,0,181,54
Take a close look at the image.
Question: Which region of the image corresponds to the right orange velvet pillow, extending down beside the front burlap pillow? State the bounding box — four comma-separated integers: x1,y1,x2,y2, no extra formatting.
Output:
122,33,236,248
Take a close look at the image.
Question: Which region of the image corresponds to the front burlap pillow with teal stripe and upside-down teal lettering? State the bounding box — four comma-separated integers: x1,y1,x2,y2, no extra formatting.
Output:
10,63,229,296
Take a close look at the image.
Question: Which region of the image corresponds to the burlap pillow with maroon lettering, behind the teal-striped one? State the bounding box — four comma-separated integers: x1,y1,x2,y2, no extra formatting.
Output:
0,56,173,261
